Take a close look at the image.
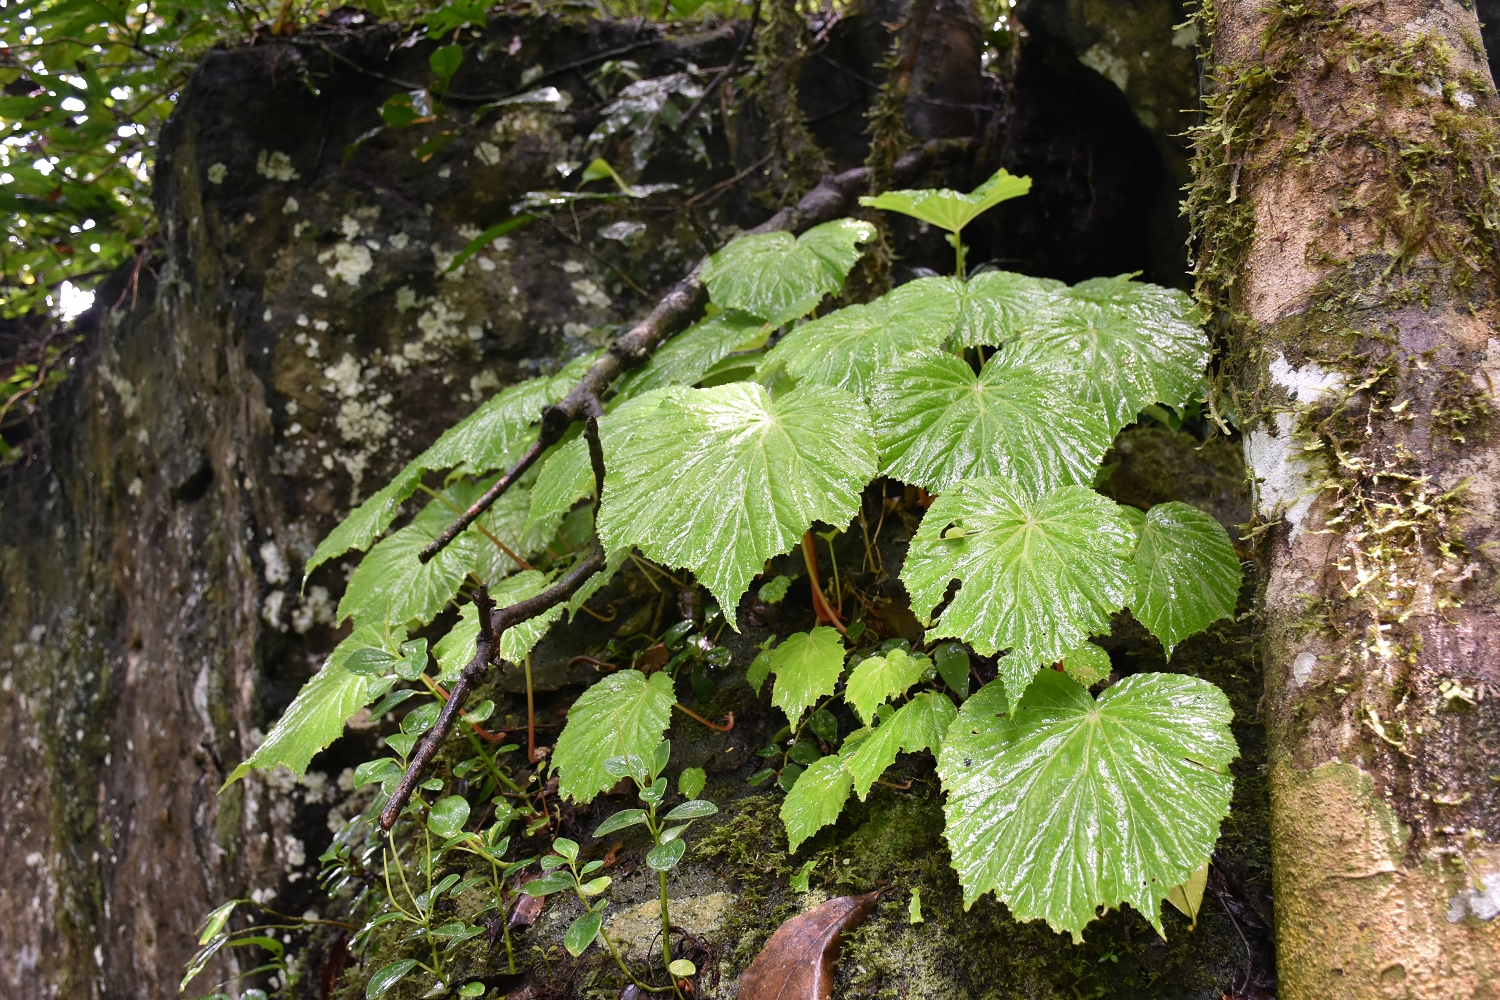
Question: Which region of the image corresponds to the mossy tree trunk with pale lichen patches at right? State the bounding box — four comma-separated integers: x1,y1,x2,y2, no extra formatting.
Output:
1190,0,1500,1000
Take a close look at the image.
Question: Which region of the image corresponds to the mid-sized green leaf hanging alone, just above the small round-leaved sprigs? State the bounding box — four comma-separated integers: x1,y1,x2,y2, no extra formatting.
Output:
552,670,677,802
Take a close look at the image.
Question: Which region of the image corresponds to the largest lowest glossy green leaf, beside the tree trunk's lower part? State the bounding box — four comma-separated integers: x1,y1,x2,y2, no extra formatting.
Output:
938,670,1239,942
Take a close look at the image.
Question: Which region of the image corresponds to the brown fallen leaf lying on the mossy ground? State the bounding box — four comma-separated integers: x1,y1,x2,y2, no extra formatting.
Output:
740,889,884,1000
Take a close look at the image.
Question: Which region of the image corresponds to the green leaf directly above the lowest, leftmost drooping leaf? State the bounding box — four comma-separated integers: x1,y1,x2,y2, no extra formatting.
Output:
339,483,491,625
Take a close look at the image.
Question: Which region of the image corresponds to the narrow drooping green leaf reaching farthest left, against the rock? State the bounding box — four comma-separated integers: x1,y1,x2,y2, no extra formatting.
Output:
225,625,407,786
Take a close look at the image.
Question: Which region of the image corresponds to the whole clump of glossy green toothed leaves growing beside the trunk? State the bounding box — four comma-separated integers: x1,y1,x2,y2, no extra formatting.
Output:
236,164,1239,970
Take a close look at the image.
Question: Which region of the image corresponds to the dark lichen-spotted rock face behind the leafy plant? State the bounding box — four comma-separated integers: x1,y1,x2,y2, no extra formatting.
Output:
0,3,1230,999
